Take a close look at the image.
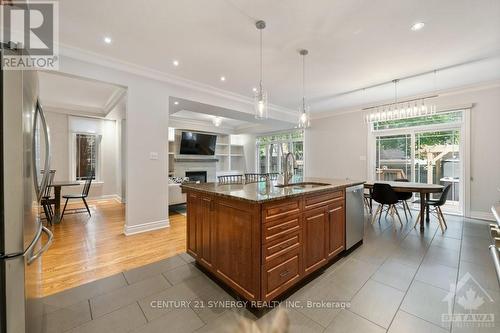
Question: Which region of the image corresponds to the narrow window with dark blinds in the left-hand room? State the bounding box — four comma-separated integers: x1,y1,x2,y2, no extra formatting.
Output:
74,134,101,180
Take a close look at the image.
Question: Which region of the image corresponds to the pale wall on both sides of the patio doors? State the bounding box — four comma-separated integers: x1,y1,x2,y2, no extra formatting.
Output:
306,84,500,217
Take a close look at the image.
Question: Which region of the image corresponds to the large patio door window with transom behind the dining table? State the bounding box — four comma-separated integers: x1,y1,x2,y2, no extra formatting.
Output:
369,110,467,213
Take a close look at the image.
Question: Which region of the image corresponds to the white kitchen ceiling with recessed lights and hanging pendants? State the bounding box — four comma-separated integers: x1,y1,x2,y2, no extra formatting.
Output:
54,0,500,112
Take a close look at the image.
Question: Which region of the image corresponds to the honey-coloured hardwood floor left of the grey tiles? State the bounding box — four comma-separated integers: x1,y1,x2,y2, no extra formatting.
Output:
42,199,186,296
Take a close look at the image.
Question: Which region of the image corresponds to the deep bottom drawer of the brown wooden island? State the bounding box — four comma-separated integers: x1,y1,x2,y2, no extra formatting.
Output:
262,248,301,300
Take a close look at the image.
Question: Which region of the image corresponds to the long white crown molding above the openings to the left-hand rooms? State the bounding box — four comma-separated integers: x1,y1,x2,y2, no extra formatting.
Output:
59,44,296,115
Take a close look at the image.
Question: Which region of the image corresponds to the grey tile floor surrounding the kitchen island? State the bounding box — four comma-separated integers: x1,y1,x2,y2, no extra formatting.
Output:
44,211,500,333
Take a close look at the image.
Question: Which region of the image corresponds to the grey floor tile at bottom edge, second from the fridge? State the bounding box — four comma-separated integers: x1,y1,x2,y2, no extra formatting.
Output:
71,303,146,333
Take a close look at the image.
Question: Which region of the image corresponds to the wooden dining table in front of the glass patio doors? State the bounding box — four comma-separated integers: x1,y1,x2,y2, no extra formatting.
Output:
364,180,444,231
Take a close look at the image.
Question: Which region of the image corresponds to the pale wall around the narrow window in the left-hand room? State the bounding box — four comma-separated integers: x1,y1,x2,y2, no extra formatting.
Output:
45,112,120,198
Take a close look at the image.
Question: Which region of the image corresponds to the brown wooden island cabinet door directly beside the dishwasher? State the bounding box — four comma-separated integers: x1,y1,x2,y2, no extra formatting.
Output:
327,200,345,258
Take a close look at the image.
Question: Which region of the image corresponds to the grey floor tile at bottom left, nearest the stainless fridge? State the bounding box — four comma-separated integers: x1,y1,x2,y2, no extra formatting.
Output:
43,300,92,333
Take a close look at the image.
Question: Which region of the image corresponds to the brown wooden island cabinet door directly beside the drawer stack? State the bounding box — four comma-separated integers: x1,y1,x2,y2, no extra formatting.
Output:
304,208,327,274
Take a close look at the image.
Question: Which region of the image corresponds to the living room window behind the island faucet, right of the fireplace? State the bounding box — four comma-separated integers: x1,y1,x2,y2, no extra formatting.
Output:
257,130,304,176
